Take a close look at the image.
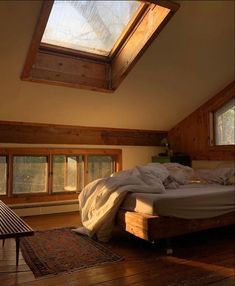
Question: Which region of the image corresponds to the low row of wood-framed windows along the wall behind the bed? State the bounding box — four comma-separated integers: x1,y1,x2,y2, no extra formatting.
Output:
0,148,121,203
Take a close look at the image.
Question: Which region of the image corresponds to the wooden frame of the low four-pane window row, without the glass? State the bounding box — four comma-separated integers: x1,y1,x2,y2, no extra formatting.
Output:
0,148,122,204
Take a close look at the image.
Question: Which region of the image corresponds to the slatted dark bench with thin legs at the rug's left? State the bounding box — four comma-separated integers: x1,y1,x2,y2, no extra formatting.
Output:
0,201,34,266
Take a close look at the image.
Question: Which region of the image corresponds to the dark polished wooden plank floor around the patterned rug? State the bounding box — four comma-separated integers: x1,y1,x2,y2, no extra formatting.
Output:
0,213,235,286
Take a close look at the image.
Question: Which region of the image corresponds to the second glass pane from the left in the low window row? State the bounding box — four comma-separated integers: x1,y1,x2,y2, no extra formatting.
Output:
13,156,48,194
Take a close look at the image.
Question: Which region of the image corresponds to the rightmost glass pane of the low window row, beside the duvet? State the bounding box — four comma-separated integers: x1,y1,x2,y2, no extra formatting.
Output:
88,155,115,182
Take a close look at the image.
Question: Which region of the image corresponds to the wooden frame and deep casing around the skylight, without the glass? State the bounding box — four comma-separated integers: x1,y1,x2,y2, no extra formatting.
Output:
21,0,179,92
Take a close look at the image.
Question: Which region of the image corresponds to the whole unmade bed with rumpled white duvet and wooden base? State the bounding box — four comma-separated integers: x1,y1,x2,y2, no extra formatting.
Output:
75,163,235,242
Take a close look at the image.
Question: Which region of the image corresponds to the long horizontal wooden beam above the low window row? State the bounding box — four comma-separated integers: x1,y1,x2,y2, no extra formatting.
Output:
0,121,167,146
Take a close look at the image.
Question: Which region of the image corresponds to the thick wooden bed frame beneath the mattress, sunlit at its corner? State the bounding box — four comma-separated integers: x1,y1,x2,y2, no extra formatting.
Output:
117,210,235,242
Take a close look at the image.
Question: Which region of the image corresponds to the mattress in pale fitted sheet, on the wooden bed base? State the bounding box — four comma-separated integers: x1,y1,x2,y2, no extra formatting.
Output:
121,184,235,219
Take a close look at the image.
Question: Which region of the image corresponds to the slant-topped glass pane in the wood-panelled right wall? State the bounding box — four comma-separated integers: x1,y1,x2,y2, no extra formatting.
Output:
214,100,235,145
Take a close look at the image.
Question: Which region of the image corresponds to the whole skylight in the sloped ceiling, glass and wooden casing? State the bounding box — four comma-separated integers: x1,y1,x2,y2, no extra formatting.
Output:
21,0,179,92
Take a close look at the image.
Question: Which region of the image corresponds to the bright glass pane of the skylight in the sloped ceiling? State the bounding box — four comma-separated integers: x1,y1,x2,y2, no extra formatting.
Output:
42,0,141,56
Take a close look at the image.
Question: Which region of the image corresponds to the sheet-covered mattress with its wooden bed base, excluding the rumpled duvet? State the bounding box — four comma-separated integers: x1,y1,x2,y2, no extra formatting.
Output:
116,185,235,242
